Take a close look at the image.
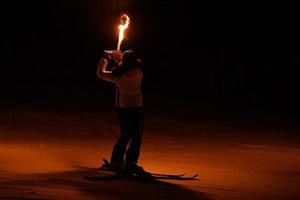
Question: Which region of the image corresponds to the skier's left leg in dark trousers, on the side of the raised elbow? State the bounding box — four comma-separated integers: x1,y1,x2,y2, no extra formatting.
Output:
110,108,132,165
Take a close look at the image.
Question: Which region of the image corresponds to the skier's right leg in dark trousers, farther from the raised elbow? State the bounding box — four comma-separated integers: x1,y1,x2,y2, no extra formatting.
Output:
125,108,144,164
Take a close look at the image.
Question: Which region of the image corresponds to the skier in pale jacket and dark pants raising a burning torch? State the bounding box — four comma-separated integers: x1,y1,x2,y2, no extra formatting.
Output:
97,14,145,174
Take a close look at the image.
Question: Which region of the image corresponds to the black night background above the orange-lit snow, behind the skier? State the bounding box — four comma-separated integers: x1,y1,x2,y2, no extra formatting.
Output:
0,0,300,116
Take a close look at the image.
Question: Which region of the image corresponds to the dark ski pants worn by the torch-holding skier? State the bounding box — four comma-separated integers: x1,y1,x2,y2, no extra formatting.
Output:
111,107,143,163
